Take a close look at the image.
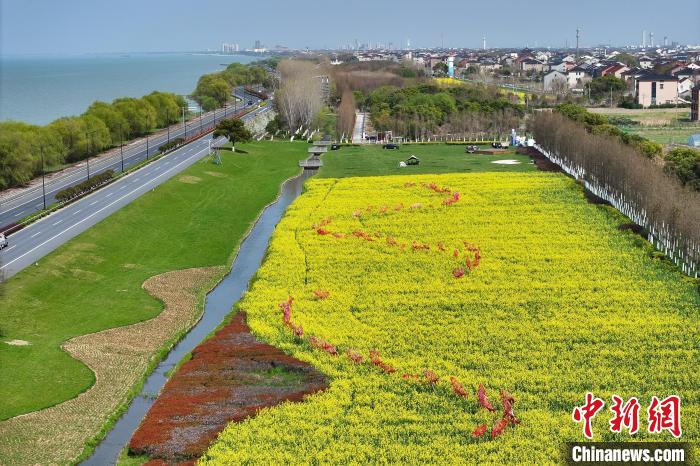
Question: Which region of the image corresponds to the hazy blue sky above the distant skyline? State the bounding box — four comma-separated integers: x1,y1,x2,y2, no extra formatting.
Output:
0,0,700,55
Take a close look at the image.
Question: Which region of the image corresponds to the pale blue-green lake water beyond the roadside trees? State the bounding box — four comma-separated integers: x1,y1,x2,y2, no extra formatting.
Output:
0,53,257,124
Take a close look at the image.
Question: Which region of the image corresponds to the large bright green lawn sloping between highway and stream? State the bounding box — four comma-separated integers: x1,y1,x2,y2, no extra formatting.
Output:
0,142,308,419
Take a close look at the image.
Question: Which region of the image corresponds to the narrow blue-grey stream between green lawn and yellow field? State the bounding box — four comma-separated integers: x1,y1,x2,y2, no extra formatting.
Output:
82,170,315,466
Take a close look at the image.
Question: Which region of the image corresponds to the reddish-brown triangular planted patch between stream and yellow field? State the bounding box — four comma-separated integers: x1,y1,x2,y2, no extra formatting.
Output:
129,312,327,465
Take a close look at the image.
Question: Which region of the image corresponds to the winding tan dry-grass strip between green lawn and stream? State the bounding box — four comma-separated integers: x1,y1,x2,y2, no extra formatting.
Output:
0,267,223,464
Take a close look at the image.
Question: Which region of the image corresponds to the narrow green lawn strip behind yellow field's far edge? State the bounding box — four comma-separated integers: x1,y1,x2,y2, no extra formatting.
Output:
318,144,536,178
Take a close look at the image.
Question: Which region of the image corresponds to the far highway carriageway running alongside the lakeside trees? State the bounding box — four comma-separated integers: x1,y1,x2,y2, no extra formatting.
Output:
0,89,260,231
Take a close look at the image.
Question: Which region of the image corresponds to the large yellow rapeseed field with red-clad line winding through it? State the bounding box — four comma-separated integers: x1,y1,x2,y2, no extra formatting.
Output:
201,173,700,464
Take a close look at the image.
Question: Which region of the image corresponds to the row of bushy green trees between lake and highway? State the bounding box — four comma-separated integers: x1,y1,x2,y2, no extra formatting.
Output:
0,91,187,189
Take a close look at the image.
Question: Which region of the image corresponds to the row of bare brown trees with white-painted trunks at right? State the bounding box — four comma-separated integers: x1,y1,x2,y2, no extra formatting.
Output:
531,112,700,276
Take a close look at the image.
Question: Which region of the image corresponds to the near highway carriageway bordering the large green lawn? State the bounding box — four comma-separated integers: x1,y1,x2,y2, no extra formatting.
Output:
0,99,269,279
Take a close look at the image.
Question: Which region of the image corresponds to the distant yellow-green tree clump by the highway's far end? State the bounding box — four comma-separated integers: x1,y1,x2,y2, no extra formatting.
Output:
192,61,275,111
